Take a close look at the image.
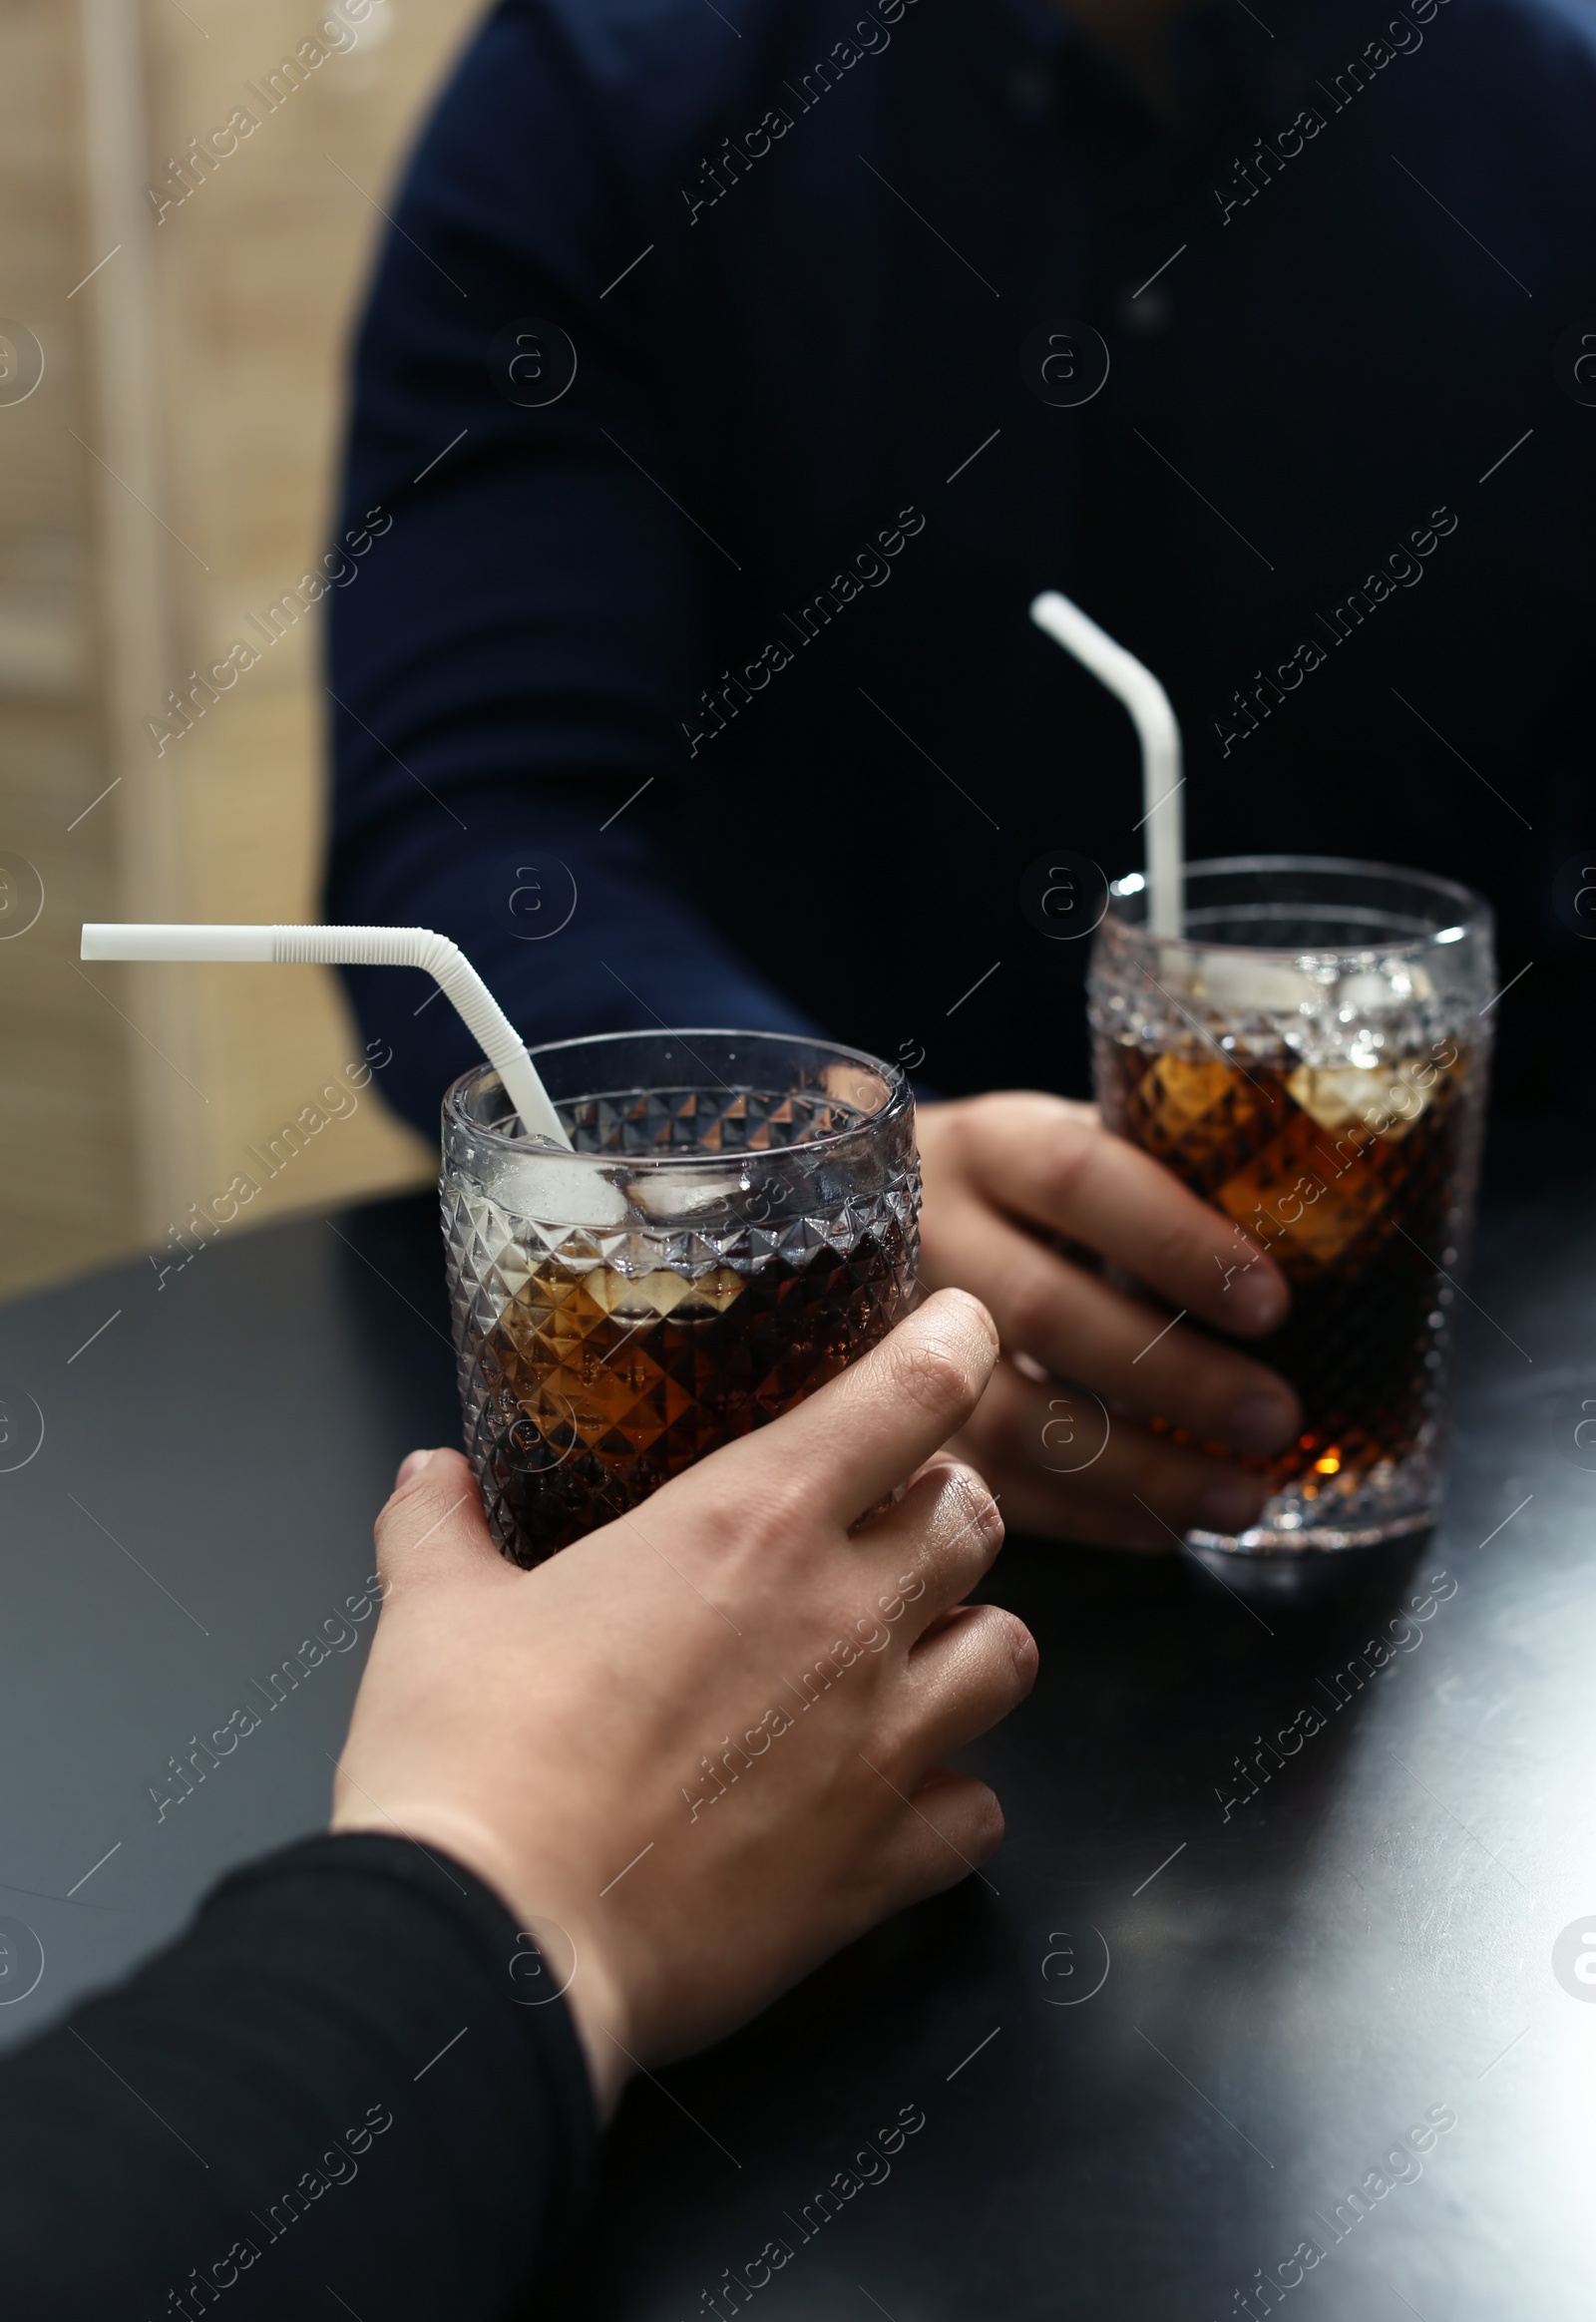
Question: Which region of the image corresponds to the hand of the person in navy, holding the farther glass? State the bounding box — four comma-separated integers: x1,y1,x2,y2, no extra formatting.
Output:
918,1091,1301,1549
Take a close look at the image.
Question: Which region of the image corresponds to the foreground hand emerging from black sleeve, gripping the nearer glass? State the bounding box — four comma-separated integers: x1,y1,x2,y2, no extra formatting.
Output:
332,1294,1036,2111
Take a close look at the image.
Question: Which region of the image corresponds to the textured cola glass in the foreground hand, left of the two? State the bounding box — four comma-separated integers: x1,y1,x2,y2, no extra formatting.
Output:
442,1031,920,1565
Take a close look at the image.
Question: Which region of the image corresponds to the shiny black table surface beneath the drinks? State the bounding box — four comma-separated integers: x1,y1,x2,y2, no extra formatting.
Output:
0,1147,1596,2322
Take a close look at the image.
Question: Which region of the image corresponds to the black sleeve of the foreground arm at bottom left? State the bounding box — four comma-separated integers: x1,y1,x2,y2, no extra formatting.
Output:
0,1834,598,2322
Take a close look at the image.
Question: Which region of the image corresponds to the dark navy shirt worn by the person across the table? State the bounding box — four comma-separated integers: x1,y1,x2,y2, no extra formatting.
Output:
325,0,1596,1128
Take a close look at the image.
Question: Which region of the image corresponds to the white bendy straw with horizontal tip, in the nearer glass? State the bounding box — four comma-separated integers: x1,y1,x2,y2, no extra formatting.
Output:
79,920,572,1152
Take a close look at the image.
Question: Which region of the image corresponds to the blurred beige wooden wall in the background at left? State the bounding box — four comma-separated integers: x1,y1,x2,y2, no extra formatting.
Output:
0,0,481,1296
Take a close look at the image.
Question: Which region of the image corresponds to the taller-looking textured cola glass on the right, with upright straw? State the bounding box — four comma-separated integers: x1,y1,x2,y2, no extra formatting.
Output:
1089,855,1496,1553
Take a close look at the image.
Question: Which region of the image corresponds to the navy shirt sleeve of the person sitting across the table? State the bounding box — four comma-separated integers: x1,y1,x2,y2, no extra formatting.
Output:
325,0,813,1135
